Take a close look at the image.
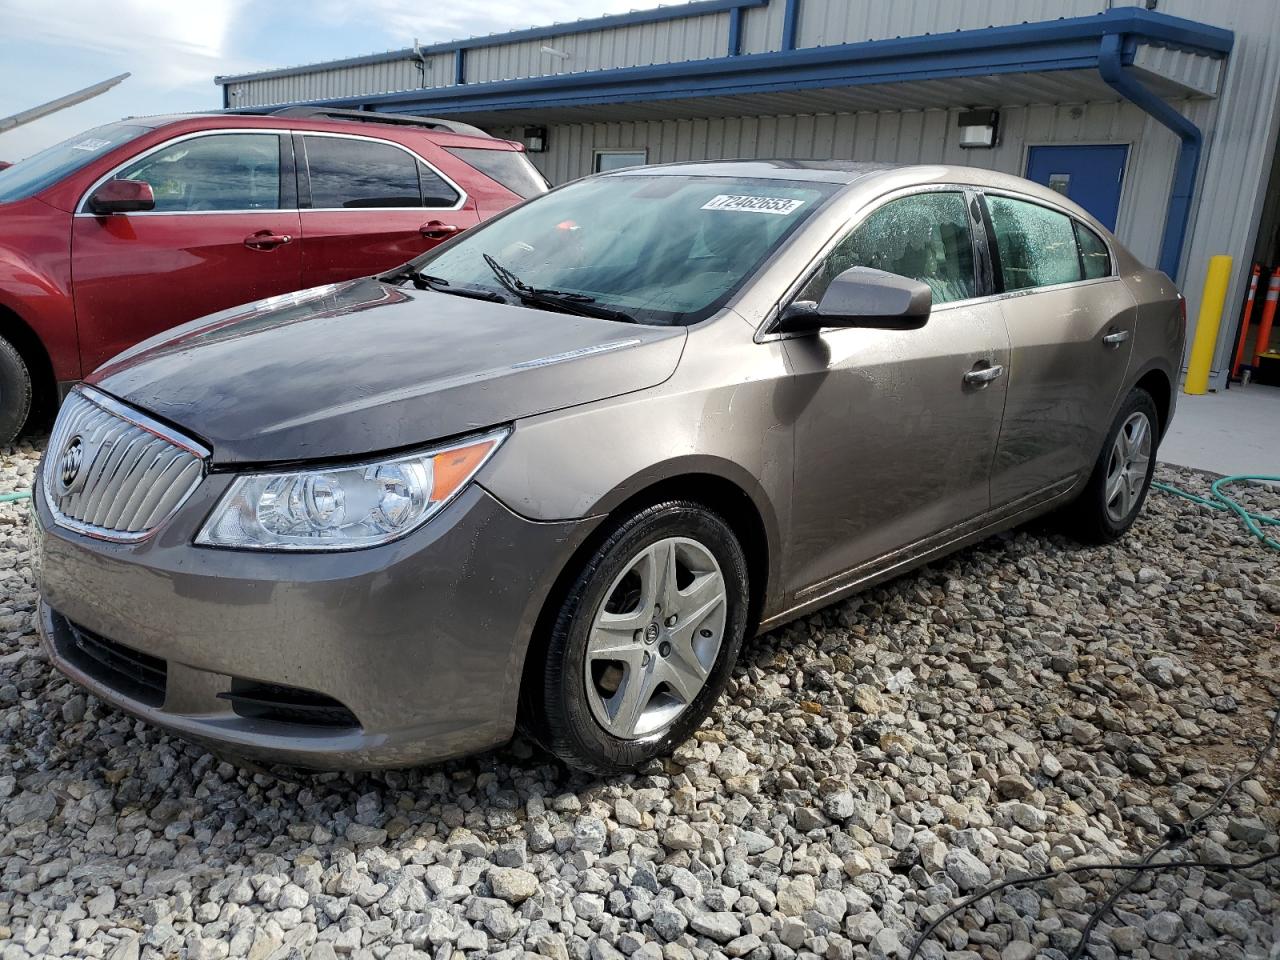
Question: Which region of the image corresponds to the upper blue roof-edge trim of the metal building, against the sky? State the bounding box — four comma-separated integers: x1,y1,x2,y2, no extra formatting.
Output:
214,0,769,84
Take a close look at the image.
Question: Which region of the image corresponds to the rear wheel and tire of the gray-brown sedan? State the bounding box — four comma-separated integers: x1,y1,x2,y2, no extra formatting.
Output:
1062,388,1160,544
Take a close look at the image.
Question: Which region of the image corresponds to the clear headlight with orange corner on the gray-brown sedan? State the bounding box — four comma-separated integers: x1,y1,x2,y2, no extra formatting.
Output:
196,430,507,550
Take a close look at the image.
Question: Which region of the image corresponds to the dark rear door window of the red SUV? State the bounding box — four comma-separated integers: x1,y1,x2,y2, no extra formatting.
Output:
302,137,422,210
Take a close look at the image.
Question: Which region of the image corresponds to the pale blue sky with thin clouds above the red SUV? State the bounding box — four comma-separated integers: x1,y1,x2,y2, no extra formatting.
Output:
0,0,658,161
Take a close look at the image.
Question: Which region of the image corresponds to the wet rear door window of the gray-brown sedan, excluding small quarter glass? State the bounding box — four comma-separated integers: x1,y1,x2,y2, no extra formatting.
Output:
987,195,1082,291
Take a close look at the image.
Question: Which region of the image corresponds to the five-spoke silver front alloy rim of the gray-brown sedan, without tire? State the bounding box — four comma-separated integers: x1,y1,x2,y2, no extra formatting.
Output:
584,536,728,740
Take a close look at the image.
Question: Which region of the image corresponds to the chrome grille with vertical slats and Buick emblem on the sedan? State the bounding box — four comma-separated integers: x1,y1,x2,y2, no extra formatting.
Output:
41,387,209,541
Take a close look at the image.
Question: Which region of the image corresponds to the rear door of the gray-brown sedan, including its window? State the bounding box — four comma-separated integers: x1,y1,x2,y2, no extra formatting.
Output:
984,191,1134,507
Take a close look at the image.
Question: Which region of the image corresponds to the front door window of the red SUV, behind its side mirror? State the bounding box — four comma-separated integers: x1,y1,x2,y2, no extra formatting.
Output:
116,133,280,212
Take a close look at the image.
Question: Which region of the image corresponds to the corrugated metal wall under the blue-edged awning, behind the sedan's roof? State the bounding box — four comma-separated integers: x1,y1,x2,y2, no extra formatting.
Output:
495,101,1212,262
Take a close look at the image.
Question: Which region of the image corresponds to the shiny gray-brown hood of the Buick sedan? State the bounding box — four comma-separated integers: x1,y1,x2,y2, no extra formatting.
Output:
87,278,685,463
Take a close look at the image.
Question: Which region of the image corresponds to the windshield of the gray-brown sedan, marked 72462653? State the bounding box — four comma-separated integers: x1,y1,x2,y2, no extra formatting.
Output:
412,174,838,325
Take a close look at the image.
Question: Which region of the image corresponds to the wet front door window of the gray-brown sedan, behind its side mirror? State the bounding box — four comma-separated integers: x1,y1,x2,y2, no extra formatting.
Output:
799,192,978,303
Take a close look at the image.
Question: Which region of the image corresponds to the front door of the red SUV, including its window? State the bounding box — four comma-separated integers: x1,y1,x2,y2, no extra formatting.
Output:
72,129,302,372
